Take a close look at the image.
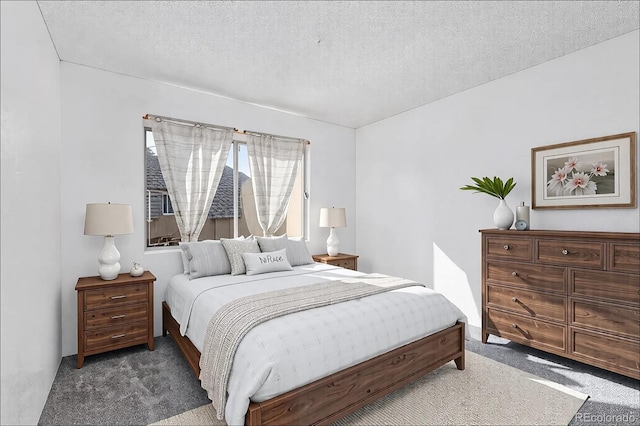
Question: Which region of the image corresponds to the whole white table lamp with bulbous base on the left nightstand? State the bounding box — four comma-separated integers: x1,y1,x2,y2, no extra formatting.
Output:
84,203,133,280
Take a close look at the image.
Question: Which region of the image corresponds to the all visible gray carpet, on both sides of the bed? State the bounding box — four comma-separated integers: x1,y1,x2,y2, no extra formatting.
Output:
39,327,640,425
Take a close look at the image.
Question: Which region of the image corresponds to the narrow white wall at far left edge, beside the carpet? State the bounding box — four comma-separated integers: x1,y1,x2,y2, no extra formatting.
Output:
0,1,61,425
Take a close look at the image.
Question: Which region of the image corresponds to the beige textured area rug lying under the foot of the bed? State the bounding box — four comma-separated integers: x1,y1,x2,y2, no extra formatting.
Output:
154,351,588,426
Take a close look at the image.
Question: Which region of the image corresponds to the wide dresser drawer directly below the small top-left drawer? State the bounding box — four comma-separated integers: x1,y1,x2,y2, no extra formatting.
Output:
485,260,566,294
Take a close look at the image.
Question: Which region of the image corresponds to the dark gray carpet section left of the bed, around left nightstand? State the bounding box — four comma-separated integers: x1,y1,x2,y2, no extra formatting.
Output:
38,336,209,425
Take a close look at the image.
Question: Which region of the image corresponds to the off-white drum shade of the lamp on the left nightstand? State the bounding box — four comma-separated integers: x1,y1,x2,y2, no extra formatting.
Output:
84,203,133,236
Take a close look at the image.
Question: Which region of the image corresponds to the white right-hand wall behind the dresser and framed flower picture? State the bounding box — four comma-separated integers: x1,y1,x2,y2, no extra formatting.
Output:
356,31,640,326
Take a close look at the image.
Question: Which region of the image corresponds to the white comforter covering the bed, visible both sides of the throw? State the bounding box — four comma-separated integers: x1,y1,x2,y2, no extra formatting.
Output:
165,263,467,425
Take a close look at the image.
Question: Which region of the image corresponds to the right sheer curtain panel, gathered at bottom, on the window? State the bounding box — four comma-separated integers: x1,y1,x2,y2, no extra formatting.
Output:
247,133,306,236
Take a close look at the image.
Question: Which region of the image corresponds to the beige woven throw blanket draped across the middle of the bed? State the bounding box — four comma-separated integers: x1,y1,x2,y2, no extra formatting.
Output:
200,274,424,420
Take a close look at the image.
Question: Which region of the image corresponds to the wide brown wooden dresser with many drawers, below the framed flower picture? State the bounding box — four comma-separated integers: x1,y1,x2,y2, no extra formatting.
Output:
480,230,640,379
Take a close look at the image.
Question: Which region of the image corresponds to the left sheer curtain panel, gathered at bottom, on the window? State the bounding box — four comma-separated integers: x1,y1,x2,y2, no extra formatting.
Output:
151,120,233,241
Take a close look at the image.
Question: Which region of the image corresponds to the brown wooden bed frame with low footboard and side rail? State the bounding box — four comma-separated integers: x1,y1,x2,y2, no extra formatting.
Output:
162,302,465,426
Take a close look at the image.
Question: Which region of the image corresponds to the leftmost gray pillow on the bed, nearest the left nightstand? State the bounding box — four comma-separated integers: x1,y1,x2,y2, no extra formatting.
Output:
183,240,231,280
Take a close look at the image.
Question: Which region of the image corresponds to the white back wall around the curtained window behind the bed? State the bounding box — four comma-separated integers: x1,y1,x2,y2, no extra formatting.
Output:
60,62,355,355
